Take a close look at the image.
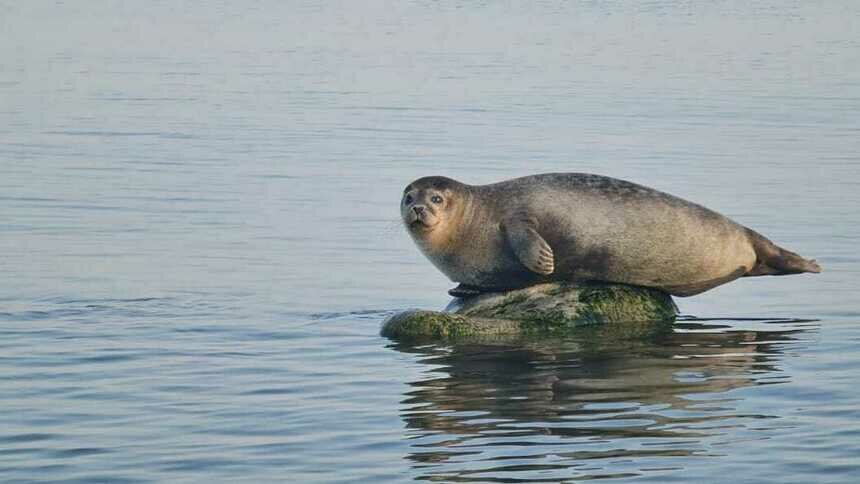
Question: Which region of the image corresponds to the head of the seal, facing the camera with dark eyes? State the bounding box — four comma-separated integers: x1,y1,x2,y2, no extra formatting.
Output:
400,176,464,246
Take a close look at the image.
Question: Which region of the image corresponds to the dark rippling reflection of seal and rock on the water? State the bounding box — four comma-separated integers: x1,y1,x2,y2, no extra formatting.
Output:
395,319,817,482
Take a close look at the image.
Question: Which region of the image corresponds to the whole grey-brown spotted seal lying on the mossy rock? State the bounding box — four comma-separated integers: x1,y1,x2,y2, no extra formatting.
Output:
400,173,821,296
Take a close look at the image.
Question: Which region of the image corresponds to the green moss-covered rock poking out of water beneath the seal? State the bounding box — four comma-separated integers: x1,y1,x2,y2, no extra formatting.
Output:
382,283,677,340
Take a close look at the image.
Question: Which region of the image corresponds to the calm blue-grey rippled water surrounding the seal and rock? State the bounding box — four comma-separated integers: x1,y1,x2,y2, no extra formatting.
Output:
0,0,860,482
